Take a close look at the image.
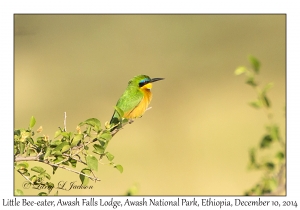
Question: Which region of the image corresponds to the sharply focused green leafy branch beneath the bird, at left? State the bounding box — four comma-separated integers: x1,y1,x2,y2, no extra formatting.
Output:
14,117,123,195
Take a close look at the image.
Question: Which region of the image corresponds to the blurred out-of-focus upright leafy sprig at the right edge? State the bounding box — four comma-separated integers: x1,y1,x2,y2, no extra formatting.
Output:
235,56,286,195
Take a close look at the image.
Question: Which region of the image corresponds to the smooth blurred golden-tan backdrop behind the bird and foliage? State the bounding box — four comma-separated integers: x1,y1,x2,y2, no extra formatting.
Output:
14,15,286,195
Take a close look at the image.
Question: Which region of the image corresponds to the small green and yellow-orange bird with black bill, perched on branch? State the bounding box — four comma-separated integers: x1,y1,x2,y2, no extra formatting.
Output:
110,75,164,125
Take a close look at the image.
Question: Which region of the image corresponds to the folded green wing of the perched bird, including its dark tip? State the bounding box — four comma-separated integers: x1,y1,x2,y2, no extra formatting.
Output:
110,86,144,124
